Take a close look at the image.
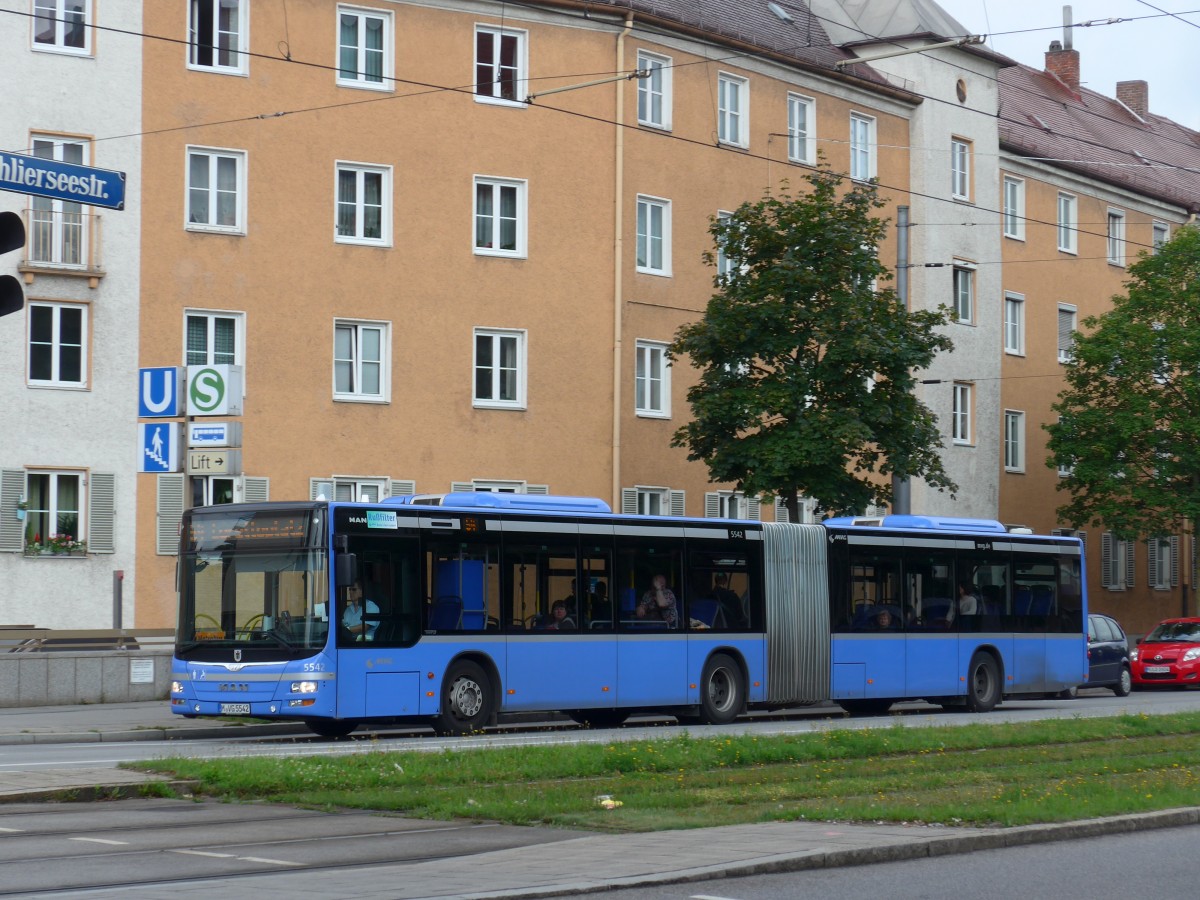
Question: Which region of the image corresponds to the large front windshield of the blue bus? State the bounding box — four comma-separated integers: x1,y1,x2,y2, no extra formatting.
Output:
176,510,329,660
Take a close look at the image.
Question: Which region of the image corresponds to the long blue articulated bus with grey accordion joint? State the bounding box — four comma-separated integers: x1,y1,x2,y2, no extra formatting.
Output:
170,493,1087,736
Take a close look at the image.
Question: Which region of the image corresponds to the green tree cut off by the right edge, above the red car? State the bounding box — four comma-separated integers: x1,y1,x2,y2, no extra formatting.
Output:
1045,226,1200,540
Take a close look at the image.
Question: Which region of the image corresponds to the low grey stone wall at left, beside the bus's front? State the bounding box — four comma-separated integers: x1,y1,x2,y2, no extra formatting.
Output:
0,625,175,707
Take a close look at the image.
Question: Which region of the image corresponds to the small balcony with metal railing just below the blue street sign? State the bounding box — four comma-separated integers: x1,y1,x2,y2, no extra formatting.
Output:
17,202,104,288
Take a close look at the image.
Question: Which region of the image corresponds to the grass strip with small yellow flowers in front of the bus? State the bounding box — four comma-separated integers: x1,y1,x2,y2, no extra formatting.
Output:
137,713,1200,832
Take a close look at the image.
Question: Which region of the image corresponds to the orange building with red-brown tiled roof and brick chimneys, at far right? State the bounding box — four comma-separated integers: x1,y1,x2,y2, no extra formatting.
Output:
1000,42,1200,634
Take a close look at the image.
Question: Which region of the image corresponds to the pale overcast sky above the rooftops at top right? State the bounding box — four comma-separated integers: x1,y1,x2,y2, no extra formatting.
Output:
937,0,1200,131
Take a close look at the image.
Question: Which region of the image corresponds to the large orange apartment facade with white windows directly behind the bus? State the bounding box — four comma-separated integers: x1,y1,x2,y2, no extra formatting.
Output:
137,0,920,626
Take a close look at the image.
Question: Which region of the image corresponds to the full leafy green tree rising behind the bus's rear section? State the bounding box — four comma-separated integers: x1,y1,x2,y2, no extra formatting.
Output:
670,167,958,522
